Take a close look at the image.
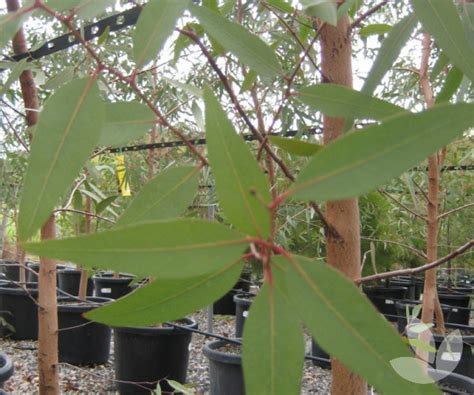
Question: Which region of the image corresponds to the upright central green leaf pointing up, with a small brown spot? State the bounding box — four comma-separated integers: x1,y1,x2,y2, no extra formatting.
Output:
204,89,271,238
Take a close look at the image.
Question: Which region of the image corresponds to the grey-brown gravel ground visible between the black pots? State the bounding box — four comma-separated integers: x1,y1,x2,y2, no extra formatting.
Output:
0,312,331,395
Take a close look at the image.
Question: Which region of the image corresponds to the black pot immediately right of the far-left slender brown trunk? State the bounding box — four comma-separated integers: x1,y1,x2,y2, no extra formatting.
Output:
58,297,112,365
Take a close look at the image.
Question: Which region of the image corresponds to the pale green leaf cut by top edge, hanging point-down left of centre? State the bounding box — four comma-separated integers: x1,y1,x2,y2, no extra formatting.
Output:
133,0,189,67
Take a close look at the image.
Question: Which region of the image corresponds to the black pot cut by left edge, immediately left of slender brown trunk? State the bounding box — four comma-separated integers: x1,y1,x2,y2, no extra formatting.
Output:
0,283,38,340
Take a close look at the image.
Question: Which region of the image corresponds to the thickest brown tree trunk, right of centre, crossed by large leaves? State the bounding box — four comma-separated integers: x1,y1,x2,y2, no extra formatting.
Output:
320,15,367,395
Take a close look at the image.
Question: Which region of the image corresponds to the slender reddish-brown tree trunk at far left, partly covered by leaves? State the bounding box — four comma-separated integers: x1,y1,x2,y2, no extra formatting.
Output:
6,0,59,395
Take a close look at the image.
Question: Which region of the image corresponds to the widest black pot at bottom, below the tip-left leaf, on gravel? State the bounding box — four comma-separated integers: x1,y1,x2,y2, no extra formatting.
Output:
114,318,197,394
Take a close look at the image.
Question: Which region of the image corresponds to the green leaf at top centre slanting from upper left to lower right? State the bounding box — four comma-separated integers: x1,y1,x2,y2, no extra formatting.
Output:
191,5,282,78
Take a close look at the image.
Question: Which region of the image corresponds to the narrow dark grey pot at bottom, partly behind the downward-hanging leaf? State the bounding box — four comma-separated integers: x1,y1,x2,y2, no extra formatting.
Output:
204,340,245,395
